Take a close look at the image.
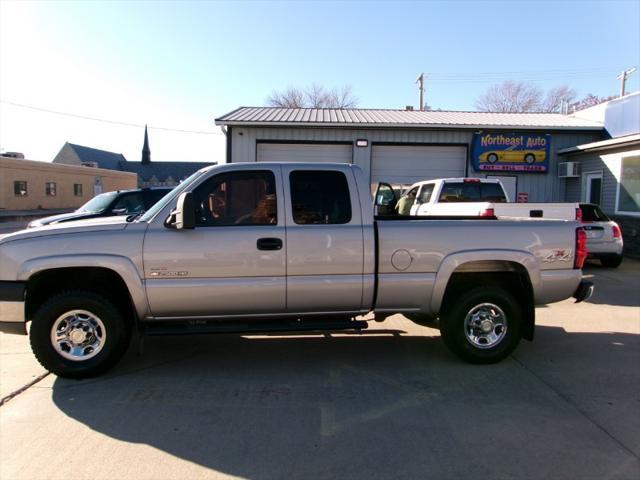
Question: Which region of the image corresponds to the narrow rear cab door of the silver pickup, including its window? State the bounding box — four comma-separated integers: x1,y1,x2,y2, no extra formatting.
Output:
282,165,364,313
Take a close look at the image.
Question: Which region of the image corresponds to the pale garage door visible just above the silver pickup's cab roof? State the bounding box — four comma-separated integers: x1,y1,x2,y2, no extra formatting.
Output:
257,143,353,163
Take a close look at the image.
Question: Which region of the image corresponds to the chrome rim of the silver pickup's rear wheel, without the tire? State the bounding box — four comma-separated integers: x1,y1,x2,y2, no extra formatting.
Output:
464,303,507,349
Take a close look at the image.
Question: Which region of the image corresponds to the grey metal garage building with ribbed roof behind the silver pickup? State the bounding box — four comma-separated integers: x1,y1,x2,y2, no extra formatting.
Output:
216,107,606,202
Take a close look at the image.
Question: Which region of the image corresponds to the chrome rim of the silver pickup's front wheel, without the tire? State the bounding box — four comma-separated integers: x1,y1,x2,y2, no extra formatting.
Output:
51,310,107,362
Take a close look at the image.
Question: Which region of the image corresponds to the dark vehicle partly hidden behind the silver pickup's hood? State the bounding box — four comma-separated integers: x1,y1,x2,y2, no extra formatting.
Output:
27,187,171,228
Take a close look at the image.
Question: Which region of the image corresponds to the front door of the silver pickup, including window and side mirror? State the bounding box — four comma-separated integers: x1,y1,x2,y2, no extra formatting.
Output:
143,165,286,317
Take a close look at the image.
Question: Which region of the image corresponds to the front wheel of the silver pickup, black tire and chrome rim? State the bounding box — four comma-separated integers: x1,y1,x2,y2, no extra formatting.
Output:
29,291,131,378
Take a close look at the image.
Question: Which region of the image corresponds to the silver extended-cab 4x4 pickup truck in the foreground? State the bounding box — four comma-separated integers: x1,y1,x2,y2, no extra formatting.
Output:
0,163,593,378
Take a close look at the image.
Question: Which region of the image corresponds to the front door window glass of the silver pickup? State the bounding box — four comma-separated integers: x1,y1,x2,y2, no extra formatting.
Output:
193,170,278,227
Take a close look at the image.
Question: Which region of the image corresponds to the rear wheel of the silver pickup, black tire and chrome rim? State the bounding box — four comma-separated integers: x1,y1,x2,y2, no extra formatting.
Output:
440,286,523,364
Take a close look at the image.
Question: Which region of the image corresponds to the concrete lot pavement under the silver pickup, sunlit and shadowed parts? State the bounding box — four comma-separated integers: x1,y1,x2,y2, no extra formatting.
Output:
0,260,640,480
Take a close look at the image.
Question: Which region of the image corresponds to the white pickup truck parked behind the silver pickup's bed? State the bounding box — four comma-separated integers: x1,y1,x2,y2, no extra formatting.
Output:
398,178,580,220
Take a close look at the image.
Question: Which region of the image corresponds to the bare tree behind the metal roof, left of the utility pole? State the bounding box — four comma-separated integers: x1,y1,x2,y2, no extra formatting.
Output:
267,83,358,108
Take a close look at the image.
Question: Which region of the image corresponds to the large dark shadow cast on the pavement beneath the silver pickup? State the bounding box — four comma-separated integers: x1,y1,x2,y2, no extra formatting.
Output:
48,327,640,479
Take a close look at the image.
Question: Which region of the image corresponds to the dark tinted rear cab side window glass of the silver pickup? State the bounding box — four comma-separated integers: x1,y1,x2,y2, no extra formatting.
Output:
289,170,351,225
